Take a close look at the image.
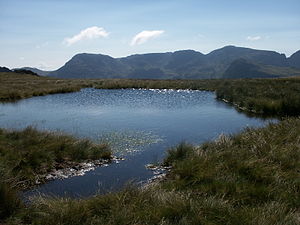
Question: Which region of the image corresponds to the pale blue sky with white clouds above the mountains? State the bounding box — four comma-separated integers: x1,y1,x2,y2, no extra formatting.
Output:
0,0,300,70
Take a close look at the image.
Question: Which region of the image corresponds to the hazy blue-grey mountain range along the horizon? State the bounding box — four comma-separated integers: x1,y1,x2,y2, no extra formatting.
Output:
14,46,300,79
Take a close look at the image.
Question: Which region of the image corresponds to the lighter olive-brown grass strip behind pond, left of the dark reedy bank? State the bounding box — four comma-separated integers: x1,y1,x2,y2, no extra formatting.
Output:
0,72,217,102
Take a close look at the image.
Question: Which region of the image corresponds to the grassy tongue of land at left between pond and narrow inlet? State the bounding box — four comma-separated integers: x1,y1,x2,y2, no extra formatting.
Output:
0,127,111,187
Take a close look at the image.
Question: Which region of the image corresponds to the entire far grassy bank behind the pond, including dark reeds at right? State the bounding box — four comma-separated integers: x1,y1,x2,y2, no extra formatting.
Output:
0,73,300,116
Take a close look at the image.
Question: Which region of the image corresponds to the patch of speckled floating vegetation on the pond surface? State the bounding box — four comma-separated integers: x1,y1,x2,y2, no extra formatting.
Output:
99,130,163,156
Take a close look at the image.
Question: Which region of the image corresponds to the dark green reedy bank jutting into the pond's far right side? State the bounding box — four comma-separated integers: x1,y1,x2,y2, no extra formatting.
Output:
216,78,300,116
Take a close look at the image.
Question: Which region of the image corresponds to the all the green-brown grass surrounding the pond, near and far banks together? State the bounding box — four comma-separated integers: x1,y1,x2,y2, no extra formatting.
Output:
0,73,300,225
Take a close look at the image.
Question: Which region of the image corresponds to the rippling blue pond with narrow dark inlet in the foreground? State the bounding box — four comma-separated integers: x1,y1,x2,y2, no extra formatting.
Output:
0,88,268,197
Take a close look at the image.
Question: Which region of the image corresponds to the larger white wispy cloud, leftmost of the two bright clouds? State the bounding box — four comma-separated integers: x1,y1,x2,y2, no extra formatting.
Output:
64,26,109,46
